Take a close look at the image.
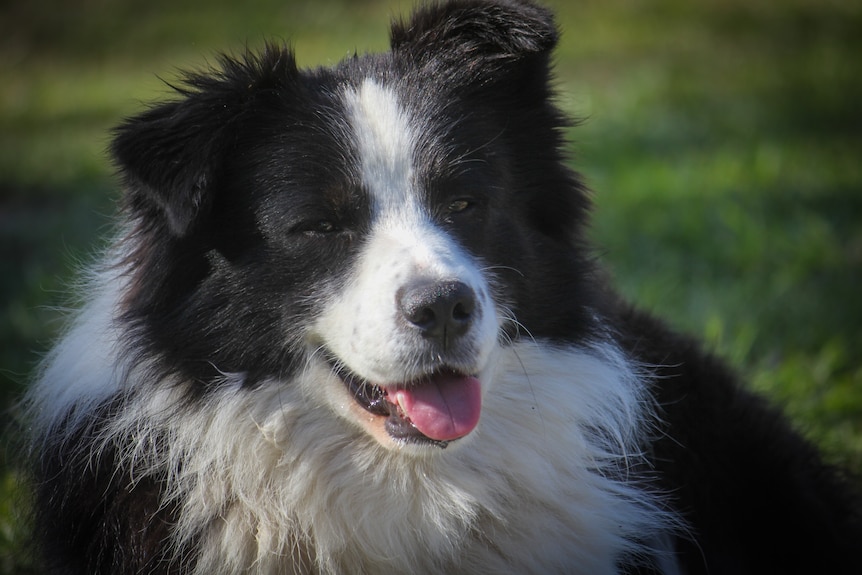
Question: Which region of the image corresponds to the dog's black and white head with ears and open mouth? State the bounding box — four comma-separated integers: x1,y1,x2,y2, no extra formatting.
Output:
112,0,591,445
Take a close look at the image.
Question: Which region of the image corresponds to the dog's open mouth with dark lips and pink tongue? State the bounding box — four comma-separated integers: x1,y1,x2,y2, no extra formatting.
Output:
329,361,482,448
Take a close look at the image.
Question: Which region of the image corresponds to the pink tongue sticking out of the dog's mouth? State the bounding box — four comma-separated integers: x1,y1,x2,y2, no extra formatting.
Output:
389,374,482,441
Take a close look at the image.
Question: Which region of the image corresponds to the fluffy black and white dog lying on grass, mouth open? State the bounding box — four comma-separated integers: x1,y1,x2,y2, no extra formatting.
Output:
30,0,862,574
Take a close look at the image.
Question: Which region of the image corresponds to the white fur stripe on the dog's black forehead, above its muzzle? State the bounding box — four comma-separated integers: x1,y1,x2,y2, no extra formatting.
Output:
346,78,413,213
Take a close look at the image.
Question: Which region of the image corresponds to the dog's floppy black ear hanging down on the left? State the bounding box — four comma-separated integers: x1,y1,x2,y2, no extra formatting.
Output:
111,46,296,237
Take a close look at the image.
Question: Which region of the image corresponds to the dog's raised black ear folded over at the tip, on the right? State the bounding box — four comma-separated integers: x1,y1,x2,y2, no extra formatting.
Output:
391,0,559,88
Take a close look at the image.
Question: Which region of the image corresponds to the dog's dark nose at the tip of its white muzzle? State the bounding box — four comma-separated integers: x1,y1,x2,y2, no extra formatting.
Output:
397,281,476,348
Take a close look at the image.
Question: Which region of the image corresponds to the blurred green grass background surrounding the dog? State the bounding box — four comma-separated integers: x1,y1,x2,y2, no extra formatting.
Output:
0,0,862,573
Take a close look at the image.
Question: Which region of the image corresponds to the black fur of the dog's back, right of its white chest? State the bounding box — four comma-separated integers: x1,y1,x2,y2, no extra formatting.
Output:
619,310,862,574
